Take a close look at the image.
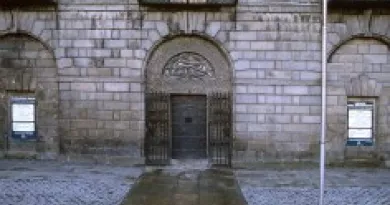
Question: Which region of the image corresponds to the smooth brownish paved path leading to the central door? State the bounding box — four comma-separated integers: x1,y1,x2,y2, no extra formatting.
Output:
122,169,246,205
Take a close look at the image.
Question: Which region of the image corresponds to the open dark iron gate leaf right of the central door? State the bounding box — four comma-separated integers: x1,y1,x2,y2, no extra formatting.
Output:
208,93,233,167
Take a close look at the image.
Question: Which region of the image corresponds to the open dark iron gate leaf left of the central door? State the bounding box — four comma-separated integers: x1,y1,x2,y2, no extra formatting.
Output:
144,92,171,165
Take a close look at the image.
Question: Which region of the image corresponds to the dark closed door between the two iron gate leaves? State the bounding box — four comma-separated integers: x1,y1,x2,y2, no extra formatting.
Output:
171,95,207,159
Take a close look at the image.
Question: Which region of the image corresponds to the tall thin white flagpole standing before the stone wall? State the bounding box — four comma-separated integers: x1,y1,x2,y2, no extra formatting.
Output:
319,0,328,205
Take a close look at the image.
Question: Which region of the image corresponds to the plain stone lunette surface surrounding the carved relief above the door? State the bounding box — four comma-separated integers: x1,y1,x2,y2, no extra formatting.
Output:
144,35,233,93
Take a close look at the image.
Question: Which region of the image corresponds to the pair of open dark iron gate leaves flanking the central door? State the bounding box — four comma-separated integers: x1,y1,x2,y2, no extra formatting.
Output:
144,92,233,167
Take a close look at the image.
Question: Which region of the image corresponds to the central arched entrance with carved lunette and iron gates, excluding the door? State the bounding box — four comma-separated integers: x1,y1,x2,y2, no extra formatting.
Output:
144,36,233,165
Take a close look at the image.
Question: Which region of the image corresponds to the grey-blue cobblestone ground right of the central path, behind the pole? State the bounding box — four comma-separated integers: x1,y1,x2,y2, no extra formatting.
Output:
236,169,390,205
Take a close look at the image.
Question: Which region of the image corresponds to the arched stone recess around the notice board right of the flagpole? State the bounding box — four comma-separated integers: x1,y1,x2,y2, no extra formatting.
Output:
327,35,390,160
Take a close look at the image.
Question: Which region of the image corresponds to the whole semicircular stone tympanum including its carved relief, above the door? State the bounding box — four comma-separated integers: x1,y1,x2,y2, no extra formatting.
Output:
146,36,232,94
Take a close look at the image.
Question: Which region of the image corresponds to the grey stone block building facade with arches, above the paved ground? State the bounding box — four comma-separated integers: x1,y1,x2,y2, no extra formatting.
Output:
0,0,390,167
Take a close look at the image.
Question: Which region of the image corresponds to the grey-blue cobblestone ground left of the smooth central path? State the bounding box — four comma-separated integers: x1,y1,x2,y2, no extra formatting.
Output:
0,160,142,205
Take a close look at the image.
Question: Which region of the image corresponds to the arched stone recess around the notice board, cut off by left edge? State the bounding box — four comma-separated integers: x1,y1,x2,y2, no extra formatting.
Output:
0,33,59,158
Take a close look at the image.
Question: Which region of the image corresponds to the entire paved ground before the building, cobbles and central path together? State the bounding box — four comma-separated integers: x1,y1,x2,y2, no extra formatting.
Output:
0,160,390,205
